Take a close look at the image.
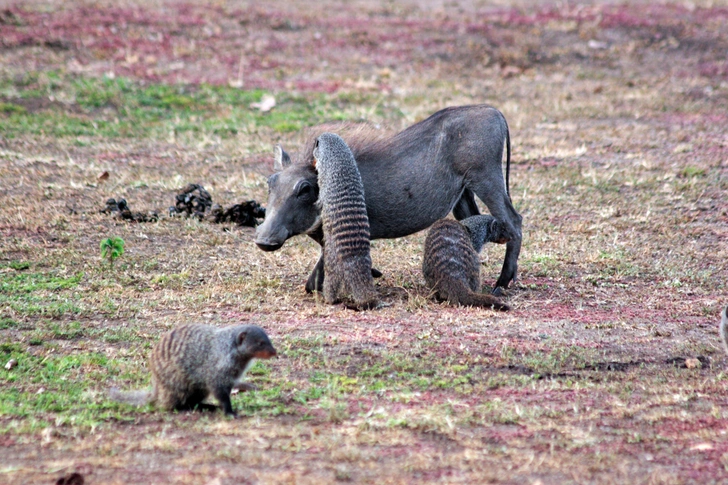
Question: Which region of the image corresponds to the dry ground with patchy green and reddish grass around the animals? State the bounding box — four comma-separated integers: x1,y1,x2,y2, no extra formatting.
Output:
0,0,728,484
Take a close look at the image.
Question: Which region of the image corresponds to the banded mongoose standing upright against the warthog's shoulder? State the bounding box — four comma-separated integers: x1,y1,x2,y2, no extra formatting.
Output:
313,133,378,309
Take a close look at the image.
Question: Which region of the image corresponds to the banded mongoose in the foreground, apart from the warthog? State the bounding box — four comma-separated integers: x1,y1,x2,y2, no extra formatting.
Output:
111,324,276,416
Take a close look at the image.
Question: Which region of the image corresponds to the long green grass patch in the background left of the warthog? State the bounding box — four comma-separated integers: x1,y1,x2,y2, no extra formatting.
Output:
0,72,376,143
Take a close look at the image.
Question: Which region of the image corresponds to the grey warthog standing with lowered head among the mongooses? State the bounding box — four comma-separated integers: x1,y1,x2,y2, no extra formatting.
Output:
255,105,522,294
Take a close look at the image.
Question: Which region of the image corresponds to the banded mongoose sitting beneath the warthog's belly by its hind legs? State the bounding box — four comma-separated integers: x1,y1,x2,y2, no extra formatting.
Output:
422,215,510,311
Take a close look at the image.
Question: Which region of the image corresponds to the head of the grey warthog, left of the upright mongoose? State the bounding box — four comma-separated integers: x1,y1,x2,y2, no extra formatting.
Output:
255,145,320,251
